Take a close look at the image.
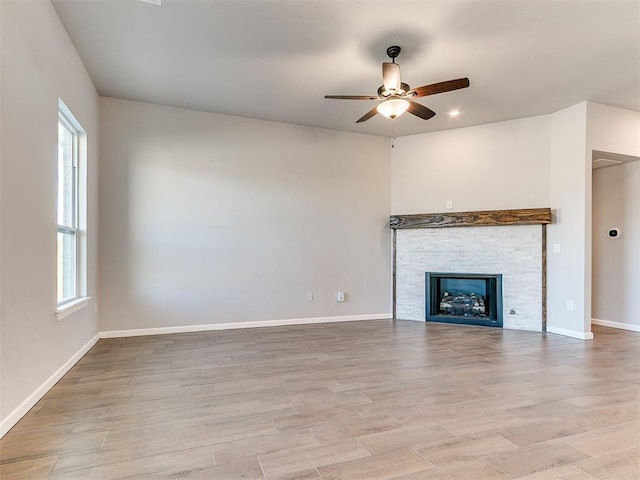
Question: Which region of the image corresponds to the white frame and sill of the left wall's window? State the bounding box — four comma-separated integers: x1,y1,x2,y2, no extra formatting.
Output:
56,100,90,320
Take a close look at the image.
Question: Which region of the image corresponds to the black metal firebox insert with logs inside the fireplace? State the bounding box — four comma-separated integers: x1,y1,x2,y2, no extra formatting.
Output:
425,272,502,327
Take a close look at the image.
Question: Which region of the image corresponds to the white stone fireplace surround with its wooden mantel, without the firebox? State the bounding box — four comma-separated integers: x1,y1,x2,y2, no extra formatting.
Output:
390,208,551,331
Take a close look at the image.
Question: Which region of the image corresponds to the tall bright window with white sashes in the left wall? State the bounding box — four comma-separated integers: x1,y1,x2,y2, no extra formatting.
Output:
57,101,86,309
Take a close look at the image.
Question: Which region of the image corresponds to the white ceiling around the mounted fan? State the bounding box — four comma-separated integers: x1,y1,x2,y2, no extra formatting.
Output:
52,0,640,136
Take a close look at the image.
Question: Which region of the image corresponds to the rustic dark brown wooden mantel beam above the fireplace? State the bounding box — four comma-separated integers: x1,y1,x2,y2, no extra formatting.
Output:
389,208,551,230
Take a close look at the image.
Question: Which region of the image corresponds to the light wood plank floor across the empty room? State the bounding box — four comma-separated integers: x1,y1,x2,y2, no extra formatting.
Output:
0,321,640,480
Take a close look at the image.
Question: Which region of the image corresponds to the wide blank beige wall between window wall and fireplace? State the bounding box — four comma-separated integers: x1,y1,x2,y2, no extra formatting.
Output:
99,98,391,331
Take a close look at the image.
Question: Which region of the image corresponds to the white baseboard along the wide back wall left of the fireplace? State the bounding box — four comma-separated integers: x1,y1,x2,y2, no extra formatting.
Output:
100,313,392,338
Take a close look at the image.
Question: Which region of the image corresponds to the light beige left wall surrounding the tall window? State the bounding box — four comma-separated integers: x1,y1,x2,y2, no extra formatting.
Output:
0,0,98,436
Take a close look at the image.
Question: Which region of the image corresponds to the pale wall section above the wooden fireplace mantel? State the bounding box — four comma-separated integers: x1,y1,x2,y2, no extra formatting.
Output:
391,116,550,215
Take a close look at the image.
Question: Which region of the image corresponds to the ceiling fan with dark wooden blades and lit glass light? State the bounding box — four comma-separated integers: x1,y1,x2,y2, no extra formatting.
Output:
324,45,469,123
